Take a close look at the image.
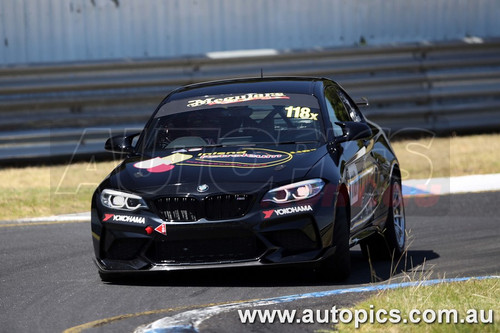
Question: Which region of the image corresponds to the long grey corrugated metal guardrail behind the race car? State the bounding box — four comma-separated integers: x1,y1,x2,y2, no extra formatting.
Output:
0,39,500,163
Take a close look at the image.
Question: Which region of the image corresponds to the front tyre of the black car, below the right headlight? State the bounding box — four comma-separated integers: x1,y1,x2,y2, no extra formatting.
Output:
318,194,351,281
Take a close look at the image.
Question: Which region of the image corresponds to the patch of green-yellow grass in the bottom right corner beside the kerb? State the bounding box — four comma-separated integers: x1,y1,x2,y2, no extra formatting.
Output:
328,279,500,333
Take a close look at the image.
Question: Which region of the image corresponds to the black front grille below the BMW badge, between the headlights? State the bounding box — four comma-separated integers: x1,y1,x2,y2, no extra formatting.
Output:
154,194,251,222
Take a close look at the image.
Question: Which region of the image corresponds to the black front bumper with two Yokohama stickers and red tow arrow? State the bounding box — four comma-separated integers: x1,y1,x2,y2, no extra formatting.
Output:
92,192,334,272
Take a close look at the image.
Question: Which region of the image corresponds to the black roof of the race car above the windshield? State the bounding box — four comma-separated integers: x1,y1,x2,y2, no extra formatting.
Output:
163,76,328,100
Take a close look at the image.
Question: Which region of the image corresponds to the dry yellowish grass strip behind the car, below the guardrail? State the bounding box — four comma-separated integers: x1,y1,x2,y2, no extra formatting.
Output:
0,134,500,220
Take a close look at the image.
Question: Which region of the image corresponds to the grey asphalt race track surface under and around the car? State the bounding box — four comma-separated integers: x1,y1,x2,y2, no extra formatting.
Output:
0,192,500,332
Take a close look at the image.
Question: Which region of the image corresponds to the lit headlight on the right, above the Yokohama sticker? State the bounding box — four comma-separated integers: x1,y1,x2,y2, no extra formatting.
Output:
262,178,325,203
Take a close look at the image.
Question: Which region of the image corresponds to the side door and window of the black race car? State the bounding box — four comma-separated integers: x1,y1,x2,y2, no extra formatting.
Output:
325,85,377,231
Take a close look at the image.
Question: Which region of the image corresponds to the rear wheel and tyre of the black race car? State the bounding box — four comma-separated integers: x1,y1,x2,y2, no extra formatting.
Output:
360,177,406,260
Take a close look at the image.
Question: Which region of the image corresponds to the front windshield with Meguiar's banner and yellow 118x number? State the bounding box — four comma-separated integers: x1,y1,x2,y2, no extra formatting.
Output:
144,92,323,152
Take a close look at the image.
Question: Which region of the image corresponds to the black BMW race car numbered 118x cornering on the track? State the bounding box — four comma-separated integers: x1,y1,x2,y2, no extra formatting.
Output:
92,77,405,280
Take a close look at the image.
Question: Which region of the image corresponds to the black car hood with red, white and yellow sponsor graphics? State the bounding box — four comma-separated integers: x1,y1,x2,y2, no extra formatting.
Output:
108,144,327,195
